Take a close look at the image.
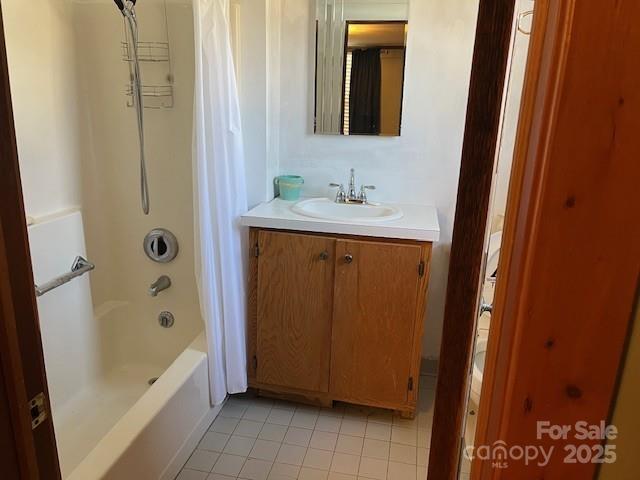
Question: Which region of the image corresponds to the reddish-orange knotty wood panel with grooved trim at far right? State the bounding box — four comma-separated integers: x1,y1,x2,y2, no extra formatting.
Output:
472,0,640,479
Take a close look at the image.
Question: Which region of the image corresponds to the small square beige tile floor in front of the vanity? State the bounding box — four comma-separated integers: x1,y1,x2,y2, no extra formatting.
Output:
177,377,435,480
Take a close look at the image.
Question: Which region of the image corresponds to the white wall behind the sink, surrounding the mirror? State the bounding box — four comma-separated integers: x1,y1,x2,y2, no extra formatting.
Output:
258,0,478,357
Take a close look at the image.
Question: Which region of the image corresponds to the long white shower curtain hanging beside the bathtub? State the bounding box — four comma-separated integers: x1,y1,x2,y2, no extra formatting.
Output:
193,0,247,405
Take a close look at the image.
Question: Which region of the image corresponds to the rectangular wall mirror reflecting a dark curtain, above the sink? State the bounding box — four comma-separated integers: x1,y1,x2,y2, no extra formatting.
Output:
314,0,408,136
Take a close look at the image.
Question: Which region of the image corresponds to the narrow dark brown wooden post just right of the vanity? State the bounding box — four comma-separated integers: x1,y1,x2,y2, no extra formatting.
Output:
428,0,515,480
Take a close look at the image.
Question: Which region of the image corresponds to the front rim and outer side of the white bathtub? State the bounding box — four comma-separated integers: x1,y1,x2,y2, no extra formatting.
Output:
67,334,221,480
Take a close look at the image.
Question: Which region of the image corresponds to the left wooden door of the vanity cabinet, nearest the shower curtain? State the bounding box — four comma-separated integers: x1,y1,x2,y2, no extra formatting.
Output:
257,231,335,392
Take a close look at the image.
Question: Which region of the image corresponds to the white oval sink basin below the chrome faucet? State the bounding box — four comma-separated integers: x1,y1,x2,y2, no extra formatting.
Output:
291,198,403,223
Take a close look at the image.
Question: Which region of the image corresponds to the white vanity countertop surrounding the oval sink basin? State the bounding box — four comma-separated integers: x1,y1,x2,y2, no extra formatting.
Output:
241,198,440,242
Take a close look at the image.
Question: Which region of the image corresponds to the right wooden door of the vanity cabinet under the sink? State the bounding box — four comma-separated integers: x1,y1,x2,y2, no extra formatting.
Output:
331,240,421,406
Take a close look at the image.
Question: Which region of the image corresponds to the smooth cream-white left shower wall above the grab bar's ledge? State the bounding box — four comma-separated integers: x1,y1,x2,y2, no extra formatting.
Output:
2,0,81,217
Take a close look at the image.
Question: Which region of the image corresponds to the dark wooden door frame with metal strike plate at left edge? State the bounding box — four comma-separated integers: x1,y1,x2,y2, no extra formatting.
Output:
0,4,60,480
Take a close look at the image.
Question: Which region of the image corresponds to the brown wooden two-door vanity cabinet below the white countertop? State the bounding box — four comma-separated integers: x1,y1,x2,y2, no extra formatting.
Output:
248,228,431,415
